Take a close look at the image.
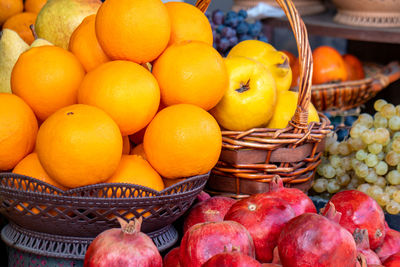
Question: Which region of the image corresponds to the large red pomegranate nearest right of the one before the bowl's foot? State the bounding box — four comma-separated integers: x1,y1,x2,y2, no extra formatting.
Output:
179,221,255,267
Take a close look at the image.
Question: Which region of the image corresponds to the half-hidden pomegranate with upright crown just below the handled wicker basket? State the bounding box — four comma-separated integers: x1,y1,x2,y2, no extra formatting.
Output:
266,175,317,216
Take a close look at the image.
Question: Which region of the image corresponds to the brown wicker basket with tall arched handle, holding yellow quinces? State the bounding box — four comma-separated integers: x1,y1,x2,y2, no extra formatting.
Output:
207,0,333,198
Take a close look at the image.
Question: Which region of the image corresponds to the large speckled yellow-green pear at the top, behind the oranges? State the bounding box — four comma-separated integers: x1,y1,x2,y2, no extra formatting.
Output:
35,0,102,49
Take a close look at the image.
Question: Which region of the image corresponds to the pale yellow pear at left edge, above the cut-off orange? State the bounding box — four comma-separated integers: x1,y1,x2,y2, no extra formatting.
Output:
0,29,29,93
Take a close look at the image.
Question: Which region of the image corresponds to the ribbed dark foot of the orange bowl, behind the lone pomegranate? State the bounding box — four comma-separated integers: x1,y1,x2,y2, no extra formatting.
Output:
1,223,178,260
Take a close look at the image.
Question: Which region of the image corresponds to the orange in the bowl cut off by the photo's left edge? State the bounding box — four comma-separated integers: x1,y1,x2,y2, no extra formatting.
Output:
0,93,38,171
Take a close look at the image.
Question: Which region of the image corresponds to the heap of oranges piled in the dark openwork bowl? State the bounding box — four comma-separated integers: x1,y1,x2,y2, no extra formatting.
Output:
0,0,228,198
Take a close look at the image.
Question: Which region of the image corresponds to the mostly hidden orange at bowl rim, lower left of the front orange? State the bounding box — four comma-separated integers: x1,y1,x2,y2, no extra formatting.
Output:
12,152,67,191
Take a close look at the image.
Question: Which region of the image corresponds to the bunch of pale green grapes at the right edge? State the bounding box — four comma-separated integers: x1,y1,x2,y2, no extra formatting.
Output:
313,99,400,214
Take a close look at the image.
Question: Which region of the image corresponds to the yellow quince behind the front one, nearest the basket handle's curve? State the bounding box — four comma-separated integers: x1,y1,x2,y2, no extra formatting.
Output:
228,40,292,91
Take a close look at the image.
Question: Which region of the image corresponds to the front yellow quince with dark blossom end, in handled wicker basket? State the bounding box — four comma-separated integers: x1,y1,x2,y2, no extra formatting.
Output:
211,57,276,131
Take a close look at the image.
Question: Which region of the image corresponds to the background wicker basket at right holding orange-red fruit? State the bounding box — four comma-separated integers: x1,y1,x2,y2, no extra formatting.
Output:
311,61,400,111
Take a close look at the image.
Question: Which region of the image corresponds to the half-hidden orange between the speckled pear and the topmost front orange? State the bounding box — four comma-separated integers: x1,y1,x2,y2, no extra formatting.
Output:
69,15,110,71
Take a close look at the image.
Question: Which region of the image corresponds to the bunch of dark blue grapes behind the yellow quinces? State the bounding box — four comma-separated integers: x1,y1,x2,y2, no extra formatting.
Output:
206,10,268,56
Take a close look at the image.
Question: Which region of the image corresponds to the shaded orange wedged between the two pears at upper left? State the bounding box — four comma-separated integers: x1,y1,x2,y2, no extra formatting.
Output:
3,12,37,45
